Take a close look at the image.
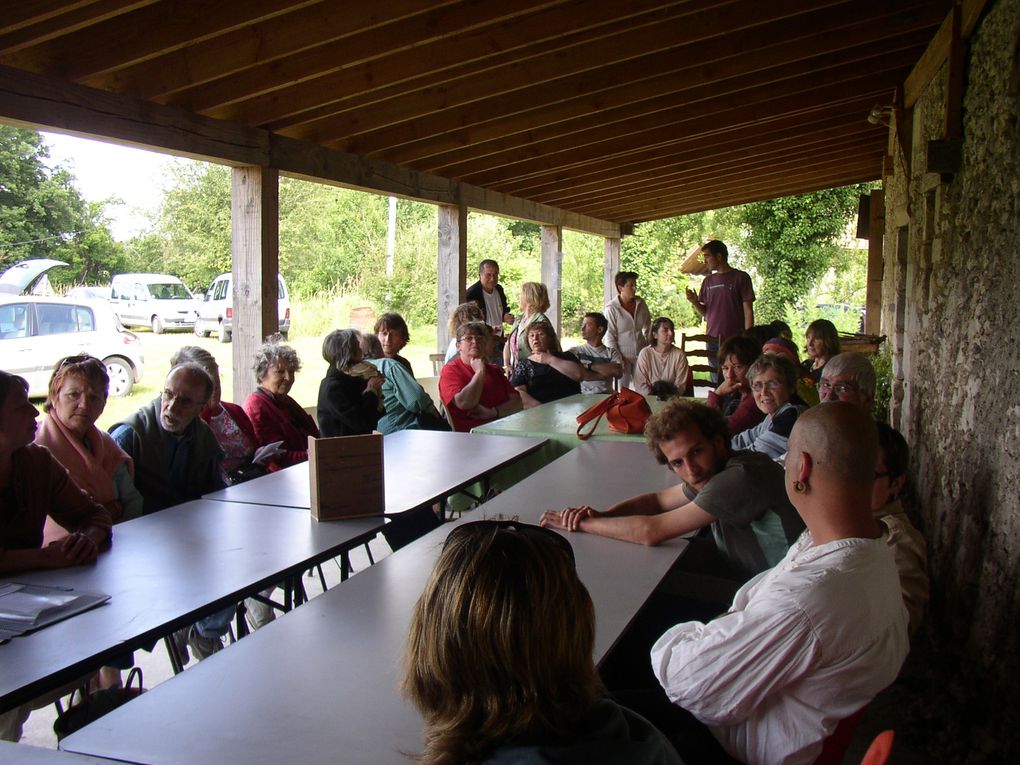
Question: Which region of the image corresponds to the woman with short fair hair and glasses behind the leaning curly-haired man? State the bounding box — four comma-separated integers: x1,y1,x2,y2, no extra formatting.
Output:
729,353,806,460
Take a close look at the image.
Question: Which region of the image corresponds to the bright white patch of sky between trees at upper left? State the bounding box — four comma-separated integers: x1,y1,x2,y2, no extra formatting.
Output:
43,133,190,242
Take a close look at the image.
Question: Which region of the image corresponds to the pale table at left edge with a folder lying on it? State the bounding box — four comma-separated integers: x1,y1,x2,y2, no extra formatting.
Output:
0,500,385,710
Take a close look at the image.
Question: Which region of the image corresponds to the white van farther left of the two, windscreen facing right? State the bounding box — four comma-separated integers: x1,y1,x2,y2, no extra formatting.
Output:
110,273,199,335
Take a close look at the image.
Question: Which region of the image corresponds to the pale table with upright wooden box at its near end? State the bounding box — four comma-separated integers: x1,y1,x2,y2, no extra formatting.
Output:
206,430,545,514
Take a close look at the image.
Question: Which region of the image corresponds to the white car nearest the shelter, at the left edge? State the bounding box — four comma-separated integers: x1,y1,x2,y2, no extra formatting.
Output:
0,294,145,397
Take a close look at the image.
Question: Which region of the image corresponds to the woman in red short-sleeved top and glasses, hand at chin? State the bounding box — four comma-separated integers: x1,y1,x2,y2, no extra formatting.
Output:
440,321,521,432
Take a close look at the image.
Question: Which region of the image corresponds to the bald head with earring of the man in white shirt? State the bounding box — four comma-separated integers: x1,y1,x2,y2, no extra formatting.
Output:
789,401,878,488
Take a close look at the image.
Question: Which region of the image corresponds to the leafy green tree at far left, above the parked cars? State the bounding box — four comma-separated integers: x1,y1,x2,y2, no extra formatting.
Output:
0,125,123,284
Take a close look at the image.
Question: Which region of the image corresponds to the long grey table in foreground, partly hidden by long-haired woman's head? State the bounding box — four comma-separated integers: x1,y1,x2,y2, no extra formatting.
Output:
62,442,686,765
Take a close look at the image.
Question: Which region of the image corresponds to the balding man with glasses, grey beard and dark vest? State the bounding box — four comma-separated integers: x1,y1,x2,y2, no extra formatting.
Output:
110,363,224,514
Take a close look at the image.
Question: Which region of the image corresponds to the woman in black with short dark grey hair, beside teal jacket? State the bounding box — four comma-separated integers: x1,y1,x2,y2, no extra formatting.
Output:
317,329,383,437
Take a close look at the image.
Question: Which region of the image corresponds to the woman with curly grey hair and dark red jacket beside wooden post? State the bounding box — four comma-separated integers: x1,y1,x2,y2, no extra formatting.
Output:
245,336,319,472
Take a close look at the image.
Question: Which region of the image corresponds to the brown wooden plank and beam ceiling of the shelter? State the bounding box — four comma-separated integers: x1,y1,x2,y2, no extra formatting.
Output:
0,0,954,224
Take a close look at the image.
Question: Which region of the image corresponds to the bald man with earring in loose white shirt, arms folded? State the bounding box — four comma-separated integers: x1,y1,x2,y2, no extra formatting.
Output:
652,402,908,765
